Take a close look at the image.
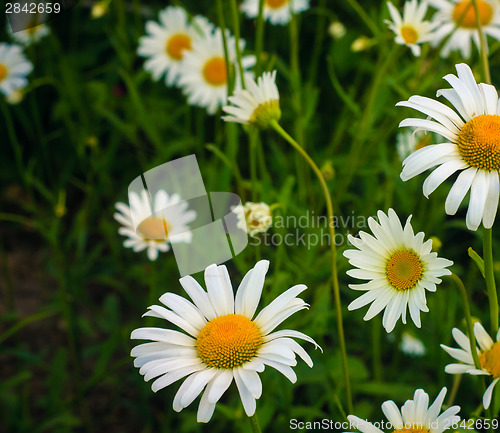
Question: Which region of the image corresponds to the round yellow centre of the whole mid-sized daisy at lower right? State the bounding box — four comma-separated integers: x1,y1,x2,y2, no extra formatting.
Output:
386,251,423,290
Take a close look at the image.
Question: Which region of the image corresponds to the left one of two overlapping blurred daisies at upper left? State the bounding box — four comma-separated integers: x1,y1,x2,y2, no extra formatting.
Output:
137,6,213,86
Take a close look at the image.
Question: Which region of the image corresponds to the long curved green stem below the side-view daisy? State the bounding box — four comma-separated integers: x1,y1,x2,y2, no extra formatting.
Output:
271,120,353,413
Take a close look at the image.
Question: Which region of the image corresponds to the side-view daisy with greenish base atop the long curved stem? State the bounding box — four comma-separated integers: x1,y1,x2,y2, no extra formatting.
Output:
222,71,281,128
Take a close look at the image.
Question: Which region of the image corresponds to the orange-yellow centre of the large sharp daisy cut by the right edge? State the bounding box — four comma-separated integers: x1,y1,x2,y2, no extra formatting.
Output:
457,114,500,171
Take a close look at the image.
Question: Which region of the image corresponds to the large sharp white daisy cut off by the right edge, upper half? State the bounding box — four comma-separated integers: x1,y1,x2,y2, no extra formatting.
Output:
396,63,500,230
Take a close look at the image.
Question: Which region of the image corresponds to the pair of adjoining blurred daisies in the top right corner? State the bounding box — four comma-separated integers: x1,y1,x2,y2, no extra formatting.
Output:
387,0,500,58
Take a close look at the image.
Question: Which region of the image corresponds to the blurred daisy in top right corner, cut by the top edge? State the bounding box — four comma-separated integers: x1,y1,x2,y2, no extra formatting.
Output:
429,0,500,59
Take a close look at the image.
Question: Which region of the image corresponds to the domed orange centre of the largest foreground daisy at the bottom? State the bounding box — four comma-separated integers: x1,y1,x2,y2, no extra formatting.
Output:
196,314,263,369
